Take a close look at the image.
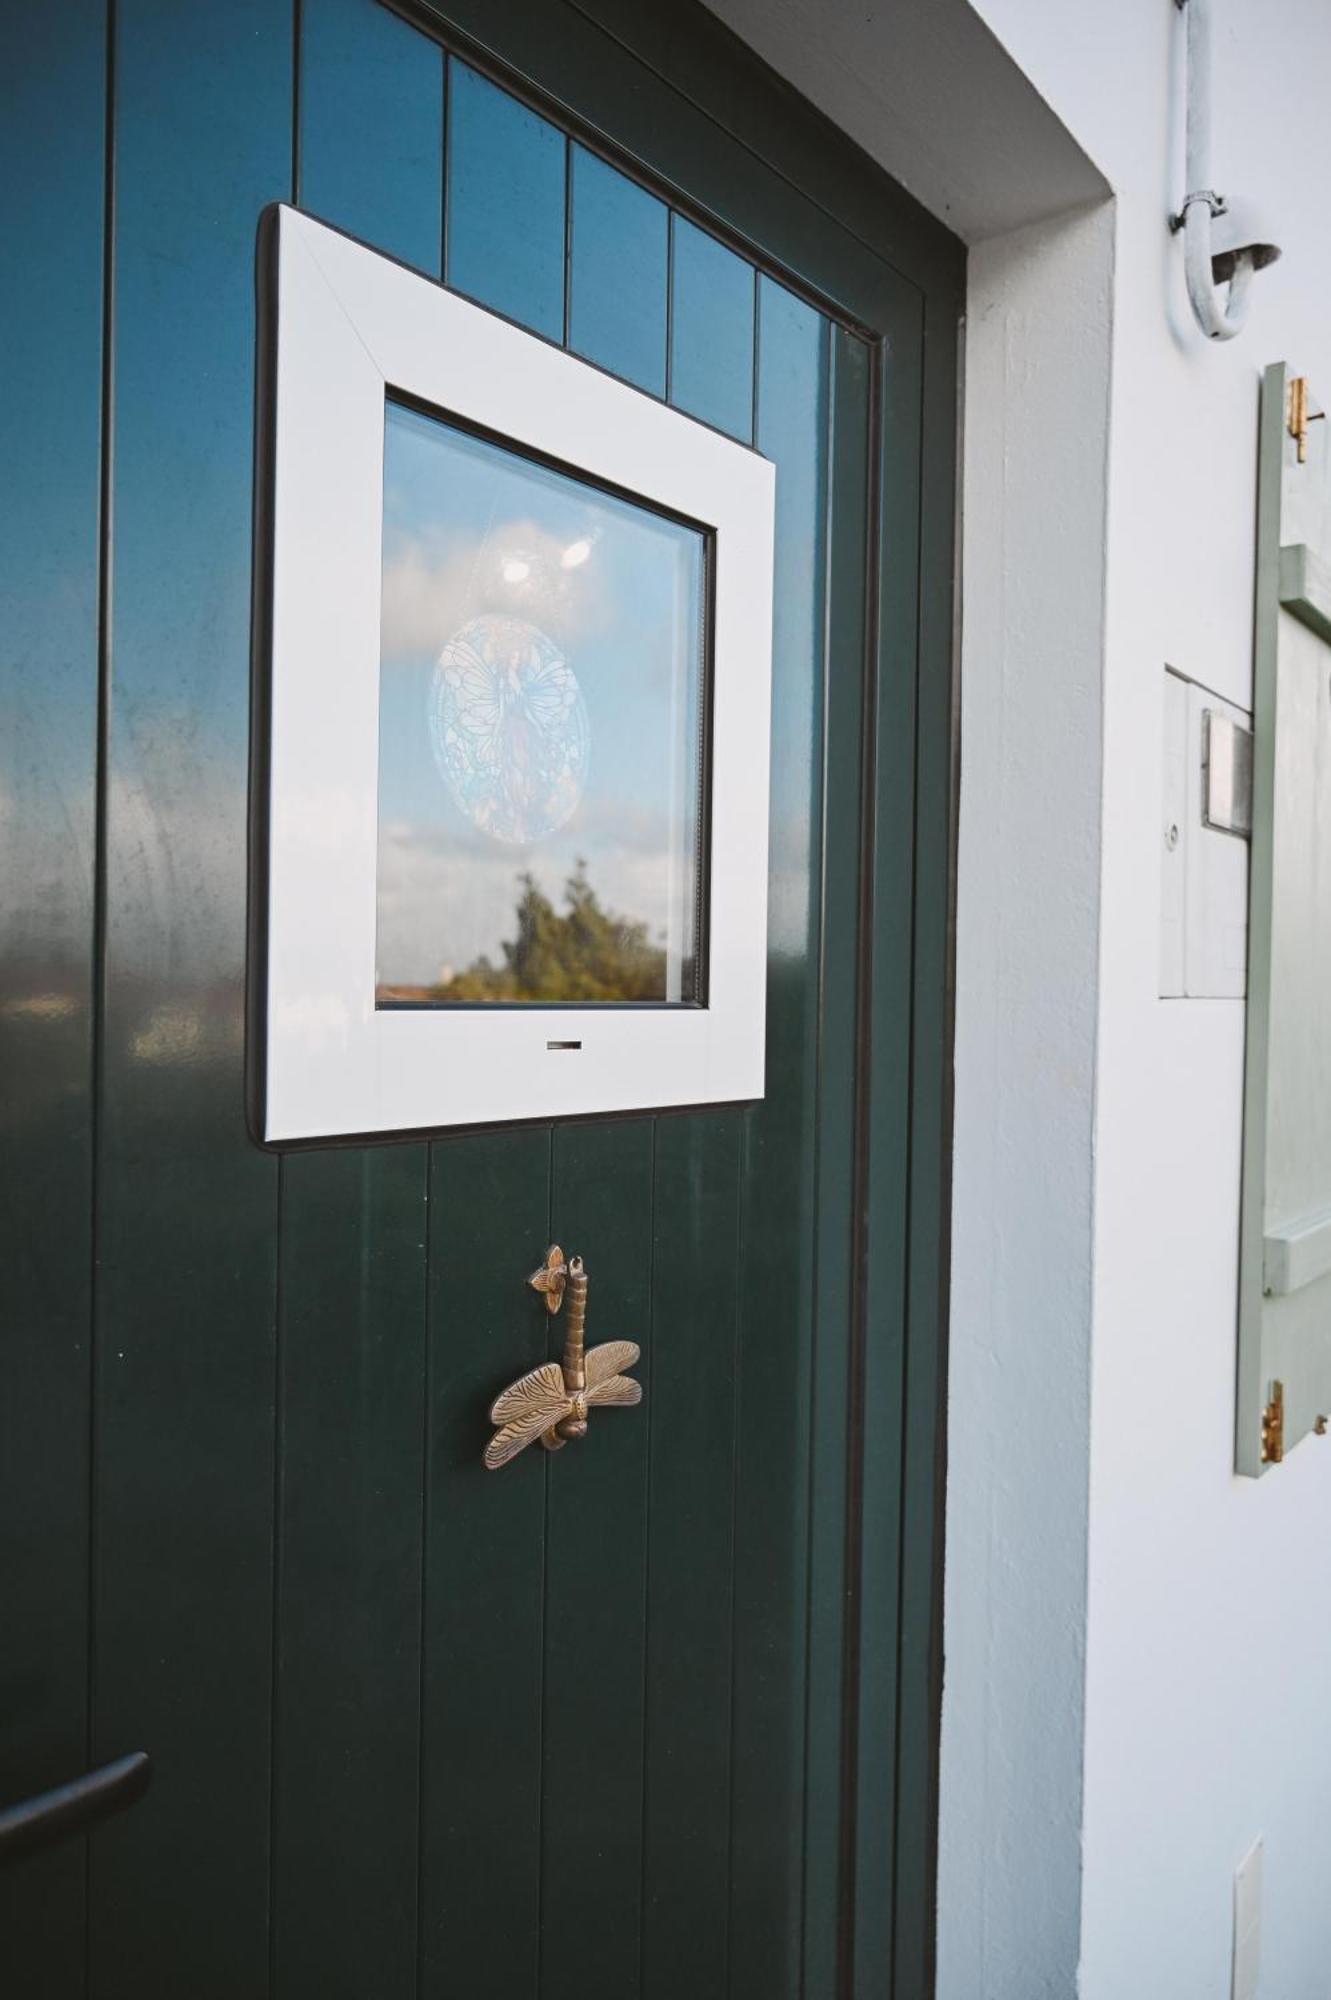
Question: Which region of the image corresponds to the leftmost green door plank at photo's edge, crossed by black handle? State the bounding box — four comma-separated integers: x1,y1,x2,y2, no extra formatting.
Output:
0,0,106,2000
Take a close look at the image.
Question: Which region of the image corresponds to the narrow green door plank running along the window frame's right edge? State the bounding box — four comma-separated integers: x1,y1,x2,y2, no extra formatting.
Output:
731,278,831,2000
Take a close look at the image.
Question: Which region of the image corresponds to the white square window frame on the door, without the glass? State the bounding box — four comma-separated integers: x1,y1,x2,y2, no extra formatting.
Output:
252,208,775,1144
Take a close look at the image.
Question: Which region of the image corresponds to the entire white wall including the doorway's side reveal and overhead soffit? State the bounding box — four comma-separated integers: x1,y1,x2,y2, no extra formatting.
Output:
713,0,1331,2000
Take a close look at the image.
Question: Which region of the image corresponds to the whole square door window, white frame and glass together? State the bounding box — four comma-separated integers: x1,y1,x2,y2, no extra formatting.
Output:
250,208,775,1144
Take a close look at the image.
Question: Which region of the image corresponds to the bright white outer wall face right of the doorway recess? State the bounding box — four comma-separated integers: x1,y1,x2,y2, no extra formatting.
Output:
969,0,1331,2000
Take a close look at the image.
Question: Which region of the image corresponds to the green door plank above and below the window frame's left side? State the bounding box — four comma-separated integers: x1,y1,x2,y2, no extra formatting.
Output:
272,11,444,2000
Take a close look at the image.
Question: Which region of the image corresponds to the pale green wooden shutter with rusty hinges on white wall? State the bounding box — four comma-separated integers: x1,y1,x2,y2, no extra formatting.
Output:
1237,364,1331,1474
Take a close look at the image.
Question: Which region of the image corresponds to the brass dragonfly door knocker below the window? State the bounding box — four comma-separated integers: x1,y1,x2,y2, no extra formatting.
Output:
486,1244,642,1472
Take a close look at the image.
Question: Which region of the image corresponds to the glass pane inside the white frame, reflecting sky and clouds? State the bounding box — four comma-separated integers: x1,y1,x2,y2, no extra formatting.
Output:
378,402,703,1002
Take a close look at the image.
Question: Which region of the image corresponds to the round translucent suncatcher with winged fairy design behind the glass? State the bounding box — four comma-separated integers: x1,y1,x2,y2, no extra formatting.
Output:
430,612,592,846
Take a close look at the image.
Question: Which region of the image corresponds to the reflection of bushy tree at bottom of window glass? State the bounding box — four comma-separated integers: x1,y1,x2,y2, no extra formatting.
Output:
430,860,666,1000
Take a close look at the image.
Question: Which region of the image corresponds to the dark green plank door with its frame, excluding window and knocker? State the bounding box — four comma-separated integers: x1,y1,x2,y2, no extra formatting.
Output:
0,0,961,2000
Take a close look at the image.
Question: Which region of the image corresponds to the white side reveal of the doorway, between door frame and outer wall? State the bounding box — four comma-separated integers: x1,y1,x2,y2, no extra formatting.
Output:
937,202,1115,2000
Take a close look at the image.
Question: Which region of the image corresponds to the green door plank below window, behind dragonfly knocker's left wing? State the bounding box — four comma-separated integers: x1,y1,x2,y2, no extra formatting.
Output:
420,1126,551,1996
